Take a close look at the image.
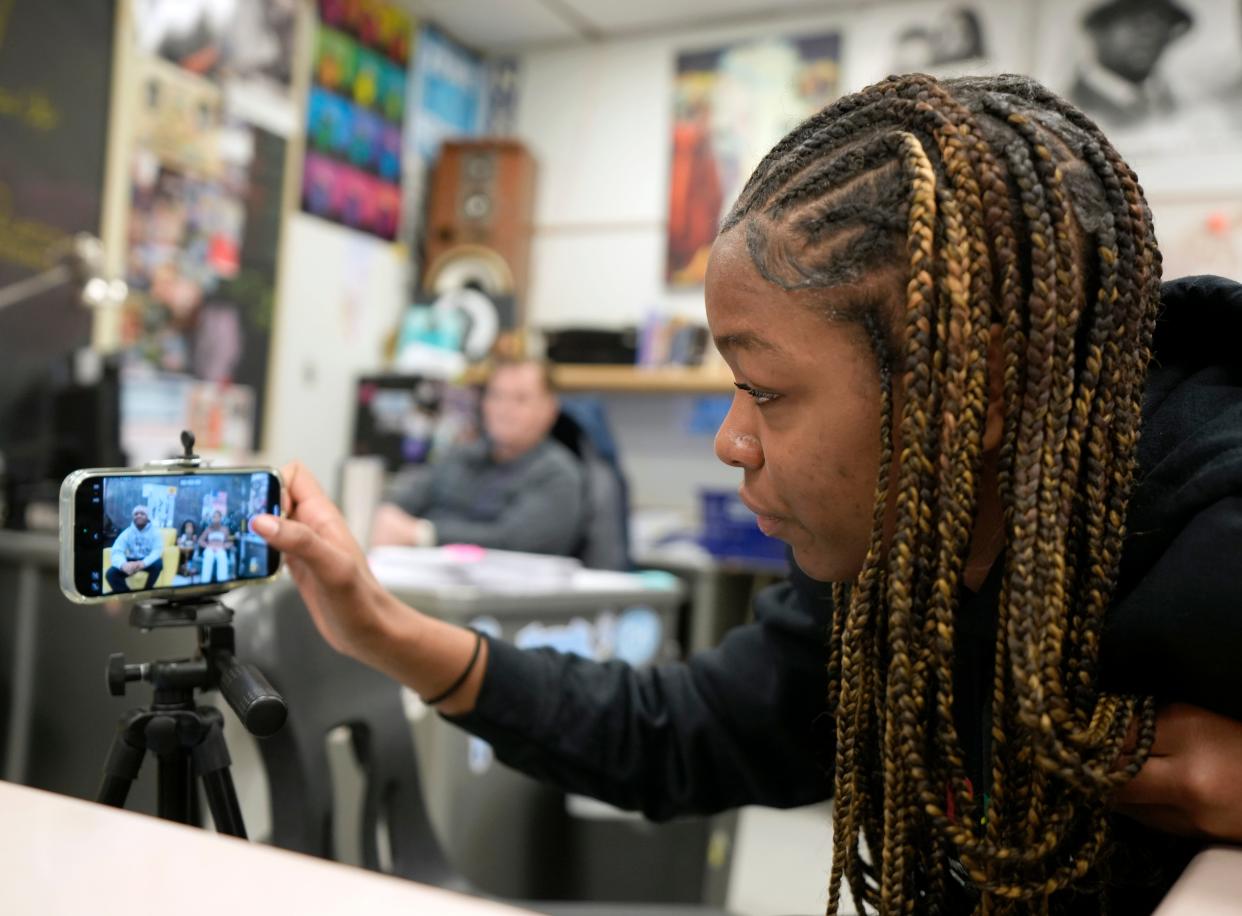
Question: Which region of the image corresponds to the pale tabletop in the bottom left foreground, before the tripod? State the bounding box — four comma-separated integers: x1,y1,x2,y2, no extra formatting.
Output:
0,783,536,916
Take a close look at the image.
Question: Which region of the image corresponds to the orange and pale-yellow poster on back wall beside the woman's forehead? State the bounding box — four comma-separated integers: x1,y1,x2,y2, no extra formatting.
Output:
666,32,841,285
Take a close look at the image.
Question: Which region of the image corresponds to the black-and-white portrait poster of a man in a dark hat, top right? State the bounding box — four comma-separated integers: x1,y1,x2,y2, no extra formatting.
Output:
1036,0,1242,155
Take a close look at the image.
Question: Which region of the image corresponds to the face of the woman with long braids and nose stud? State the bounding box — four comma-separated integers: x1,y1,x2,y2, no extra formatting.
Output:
705,226,904,581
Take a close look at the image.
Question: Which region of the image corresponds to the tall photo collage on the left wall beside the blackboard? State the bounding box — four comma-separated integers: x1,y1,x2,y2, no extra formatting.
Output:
120,0,298,457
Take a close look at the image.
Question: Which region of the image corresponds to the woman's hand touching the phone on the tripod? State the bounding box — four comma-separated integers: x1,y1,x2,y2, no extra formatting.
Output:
251,462,412,668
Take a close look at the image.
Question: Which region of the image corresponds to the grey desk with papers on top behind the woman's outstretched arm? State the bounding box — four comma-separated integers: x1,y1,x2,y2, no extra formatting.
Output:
370,547,733,904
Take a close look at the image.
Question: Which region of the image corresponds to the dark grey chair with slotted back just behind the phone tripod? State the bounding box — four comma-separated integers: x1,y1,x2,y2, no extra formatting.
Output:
232,580,728,916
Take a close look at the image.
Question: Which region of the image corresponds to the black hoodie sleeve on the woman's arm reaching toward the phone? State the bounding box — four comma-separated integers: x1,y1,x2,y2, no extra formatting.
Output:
451,563,832,820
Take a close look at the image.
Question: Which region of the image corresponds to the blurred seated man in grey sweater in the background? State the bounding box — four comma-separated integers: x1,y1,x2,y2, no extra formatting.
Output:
371,360,585,555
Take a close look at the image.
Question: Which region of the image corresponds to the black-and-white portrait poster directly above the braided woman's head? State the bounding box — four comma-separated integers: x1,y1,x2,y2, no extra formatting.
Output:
848,0,1035,88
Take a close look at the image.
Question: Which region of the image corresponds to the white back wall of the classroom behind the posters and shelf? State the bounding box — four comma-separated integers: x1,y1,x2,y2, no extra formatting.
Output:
506,0,1242,514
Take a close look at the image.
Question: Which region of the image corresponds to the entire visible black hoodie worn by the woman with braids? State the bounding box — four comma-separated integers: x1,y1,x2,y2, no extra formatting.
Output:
452,277,1242,820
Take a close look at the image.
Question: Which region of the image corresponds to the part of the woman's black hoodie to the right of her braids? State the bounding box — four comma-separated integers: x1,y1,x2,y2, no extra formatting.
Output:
1100,270,1242,719
